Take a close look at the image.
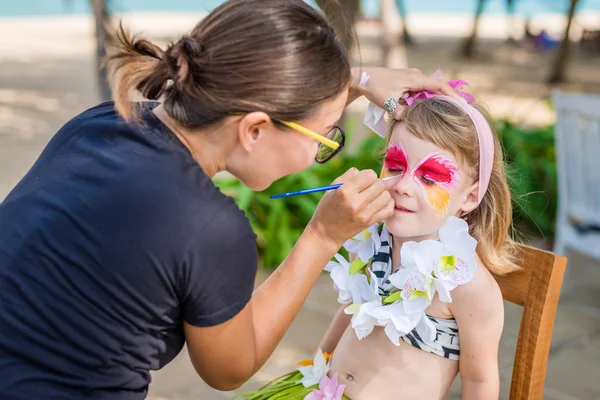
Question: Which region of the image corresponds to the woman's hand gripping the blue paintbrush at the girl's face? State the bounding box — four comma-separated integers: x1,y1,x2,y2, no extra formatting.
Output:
307,168,394,249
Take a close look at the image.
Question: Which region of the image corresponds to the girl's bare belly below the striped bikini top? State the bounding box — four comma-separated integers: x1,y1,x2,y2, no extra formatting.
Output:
329,326,458,400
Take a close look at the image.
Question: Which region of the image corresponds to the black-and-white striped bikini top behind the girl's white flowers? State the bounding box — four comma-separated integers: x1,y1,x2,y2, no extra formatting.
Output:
371,236,460,360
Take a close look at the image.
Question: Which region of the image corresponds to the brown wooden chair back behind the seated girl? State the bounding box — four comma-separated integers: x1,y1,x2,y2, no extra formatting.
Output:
496,245,567,400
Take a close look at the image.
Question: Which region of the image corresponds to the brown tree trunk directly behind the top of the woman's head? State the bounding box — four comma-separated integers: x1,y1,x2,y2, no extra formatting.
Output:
316,0,360,55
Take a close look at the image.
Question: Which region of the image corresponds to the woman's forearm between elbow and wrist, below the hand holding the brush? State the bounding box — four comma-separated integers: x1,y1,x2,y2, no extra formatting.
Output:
252,227,339,371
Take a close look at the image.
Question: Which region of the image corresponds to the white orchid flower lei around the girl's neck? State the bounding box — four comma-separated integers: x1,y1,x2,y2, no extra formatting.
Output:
325,217,477,346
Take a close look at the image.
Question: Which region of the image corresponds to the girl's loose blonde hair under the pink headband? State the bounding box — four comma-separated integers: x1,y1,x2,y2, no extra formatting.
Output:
388,98,520,275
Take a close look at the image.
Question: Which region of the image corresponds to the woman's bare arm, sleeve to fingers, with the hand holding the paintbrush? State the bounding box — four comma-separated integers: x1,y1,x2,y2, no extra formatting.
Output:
184,171,394,390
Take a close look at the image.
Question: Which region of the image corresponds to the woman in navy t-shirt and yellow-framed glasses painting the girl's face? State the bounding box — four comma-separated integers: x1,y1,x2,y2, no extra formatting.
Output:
0,0,456,399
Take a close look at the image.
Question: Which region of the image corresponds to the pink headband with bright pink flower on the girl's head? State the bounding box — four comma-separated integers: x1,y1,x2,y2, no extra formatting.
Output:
364,81,494,204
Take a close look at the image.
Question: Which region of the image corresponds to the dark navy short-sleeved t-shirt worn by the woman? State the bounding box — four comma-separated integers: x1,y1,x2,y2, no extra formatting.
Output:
0,103,257,399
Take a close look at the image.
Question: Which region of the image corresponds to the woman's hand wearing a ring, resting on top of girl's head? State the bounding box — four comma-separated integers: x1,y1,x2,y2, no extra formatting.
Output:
348,67,465,118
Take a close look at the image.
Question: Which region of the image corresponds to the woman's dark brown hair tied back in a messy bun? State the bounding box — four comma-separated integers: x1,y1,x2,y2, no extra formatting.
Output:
107,0,350,128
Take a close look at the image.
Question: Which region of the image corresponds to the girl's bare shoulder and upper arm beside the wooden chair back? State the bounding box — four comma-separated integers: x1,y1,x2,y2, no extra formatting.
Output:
450,265,504,400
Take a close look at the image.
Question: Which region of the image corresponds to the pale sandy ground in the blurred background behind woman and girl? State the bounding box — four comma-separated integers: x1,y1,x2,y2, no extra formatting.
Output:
0,8,600,400
